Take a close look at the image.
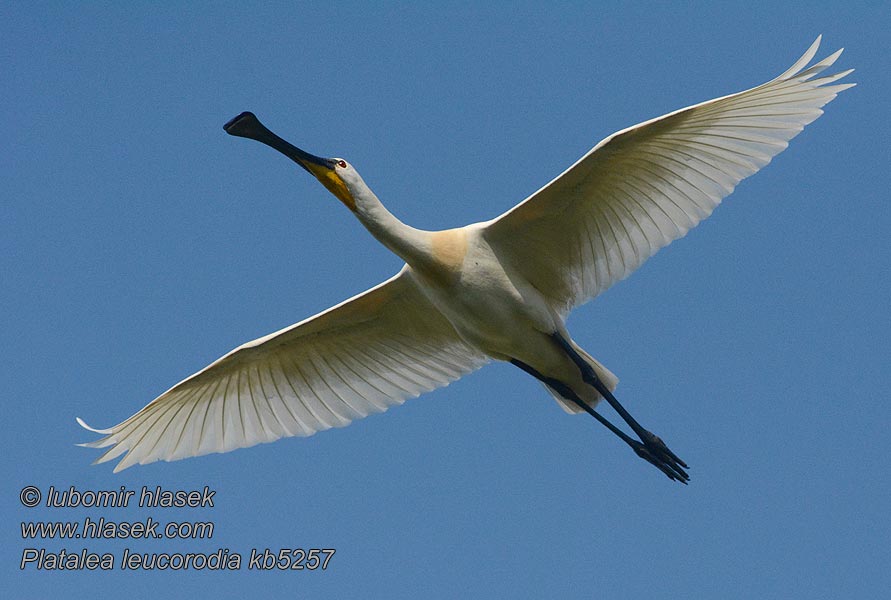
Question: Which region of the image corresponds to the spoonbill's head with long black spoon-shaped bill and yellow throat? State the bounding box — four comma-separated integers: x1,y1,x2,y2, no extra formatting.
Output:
223,112,361,212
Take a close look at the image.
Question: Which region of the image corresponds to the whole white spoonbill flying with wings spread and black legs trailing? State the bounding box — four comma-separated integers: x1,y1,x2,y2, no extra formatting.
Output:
78,37,854,483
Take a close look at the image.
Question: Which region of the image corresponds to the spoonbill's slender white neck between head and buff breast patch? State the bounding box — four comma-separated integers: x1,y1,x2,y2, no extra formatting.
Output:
355,190,431,267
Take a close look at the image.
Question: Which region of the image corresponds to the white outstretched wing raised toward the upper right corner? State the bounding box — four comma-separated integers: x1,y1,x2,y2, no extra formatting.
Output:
485,37,854,314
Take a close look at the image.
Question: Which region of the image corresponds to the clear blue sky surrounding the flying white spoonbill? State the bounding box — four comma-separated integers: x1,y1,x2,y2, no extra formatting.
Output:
0,2,891,598
